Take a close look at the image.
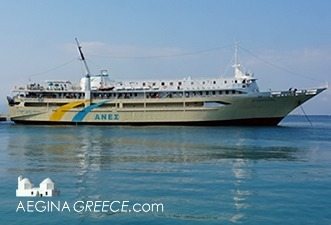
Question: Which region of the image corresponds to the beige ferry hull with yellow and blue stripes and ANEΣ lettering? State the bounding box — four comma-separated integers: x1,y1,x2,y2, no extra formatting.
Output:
10,88,324,126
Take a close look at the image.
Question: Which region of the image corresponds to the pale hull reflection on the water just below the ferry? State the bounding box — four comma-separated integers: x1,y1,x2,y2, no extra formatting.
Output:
7,127,299,170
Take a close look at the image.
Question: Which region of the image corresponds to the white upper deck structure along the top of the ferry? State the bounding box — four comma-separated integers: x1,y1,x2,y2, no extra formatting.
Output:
13,68,259,93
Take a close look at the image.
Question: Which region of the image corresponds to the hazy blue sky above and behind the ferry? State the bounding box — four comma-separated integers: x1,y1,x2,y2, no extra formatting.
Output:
0,0,331,115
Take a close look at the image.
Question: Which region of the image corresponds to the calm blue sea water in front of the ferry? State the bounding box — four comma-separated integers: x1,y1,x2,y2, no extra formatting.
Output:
0,116,331,225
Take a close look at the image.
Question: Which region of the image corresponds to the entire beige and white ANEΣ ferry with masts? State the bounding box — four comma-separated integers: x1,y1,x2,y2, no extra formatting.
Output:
7,39,326,126
